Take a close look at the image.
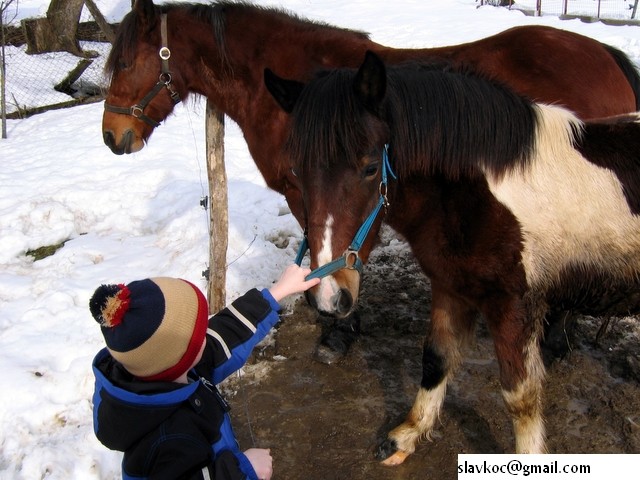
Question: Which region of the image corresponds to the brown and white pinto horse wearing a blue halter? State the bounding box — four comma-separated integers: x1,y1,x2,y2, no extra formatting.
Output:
265,52,640,465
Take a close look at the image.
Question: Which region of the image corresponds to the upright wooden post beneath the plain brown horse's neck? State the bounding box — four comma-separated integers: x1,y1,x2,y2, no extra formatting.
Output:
205,100,229,314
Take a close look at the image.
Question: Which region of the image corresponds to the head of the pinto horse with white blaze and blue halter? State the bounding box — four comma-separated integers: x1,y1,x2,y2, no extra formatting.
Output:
265,53,389,317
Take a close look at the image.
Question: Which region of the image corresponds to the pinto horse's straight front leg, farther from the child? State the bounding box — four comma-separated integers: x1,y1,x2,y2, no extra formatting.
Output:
487,297,546,453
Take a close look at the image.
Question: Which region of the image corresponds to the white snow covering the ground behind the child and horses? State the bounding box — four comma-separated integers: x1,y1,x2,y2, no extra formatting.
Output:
0,0,640,480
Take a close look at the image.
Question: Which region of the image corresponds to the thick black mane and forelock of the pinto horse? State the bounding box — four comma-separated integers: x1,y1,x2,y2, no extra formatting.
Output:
288,63,571,178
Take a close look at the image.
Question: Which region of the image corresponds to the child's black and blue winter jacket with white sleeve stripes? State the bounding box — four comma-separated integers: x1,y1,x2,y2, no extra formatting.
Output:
93,289,280,480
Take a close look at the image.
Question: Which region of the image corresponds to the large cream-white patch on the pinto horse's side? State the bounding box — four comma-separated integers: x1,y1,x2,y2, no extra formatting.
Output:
487,105,640,289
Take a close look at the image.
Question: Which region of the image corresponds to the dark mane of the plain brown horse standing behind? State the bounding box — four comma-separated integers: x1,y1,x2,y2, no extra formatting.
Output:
105,0,369,76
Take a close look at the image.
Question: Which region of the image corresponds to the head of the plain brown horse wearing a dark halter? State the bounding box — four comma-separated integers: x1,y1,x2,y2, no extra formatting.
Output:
102,0,187,155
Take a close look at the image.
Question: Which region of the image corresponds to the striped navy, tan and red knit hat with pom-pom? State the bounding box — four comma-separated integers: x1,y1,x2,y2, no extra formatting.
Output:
89,277,209,381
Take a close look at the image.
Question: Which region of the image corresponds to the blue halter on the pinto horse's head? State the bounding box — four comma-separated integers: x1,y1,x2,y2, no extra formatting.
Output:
296,144,396,280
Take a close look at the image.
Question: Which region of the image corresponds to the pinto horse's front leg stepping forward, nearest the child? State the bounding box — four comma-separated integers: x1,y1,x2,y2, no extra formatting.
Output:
376,285,477,466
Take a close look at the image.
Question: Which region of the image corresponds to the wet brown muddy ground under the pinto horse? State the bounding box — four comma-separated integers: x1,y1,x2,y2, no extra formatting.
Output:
224,237,640,480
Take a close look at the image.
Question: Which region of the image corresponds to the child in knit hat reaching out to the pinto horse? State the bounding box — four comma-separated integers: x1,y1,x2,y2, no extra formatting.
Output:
89,265,319,480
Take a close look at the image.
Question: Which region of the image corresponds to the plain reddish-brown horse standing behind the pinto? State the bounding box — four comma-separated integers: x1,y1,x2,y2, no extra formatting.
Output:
102,0,640,224
